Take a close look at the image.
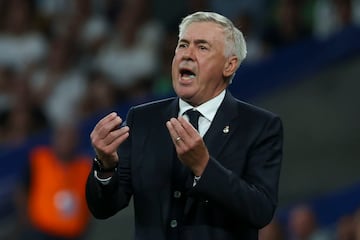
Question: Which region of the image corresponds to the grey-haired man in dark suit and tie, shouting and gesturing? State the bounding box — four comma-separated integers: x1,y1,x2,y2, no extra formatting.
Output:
87,12,282,240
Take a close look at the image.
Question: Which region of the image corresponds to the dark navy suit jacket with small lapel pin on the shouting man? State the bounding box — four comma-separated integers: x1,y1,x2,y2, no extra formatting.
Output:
86,91,283,240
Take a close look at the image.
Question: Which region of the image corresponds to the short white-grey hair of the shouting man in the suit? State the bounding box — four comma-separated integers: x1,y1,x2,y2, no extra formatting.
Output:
179,12,247,82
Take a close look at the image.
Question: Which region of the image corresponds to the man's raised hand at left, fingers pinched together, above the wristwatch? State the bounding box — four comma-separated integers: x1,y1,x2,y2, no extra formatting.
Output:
90,112,129,168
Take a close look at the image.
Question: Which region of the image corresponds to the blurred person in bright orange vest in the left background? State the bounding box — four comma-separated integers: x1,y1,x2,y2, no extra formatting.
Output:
16,125,91,240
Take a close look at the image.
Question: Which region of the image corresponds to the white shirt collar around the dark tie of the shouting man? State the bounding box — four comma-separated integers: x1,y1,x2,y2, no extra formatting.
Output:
179,89,226,122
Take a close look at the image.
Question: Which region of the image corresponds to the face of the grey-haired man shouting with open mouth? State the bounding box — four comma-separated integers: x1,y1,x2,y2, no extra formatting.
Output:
172,22,231,106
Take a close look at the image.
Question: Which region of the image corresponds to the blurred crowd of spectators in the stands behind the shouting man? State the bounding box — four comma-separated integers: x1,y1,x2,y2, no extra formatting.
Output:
0,0,360,146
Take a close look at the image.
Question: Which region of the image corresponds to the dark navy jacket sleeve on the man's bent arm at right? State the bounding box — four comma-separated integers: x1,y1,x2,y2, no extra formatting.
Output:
190,117,283,228
